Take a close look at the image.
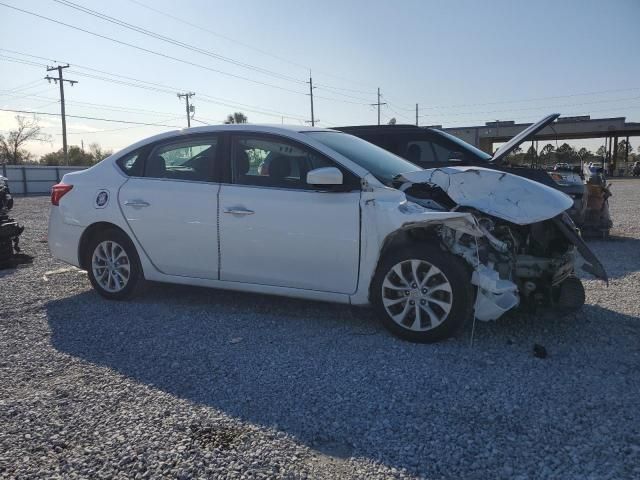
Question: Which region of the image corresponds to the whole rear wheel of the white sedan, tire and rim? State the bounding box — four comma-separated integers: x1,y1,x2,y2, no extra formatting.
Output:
85,229,144,300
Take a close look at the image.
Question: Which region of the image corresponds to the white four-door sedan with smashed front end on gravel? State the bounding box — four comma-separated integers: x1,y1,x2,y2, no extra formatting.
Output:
49,125,605,342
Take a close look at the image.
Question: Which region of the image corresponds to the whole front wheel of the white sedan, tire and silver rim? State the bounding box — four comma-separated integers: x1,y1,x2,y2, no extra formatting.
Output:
371,246,473,343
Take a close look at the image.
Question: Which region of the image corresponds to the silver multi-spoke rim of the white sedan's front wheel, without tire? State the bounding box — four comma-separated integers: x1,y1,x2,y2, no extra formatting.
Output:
382,259,453,332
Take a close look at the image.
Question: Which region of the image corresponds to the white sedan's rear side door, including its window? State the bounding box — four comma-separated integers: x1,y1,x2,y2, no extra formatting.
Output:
118,135,220,279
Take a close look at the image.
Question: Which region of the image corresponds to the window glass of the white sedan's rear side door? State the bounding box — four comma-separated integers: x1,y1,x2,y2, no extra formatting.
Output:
144,137,218,182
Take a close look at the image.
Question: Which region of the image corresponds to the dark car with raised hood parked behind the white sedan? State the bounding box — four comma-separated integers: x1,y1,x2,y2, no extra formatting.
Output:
336,114,586,225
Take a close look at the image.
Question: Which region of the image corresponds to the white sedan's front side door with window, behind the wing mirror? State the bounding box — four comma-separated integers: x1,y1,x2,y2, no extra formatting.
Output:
220,134,360,294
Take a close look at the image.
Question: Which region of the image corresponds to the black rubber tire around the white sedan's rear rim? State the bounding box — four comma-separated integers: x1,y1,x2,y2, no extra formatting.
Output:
84,228,144,300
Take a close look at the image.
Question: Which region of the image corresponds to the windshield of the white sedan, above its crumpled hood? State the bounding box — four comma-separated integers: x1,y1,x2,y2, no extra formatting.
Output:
304,132,422,185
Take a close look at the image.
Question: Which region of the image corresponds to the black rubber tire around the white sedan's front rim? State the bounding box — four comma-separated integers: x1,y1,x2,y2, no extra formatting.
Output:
371,244,474,343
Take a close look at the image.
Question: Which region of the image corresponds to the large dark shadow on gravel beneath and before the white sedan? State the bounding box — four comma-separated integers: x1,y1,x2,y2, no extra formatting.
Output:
46,285,639,477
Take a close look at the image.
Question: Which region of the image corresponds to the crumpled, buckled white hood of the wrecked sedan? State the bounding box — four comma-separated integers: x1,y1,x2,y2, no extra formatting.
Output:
399,167,573,225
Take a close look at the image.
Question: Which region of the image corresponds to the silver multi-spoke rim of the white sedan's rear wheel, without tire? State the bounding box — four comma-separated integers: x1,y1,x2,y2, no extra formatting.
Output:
91,240,131,293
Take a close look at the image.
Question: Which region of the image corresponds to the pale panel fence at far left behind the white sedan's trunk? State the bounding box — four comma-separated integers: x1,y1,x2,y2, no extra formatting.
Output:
0,164,87,195
